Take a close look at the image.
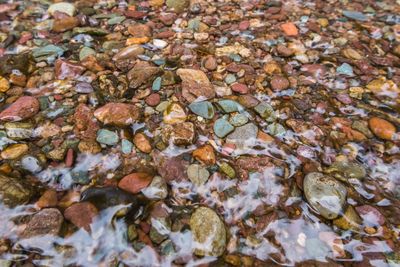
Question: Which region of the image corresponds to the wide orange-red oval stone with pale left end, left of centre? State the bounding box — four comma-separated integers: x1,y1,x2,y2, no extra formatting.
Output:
94,103,140,127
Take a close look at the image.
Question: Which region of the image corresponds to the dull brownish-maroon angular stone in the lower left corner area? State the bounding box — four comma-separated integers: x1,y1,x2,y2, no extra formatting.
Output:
21,208,64,238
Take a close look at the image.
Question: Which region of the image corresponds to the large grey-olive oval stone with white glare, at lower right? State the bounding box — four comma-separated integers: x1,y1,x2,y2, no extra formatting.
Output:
303,172,347,220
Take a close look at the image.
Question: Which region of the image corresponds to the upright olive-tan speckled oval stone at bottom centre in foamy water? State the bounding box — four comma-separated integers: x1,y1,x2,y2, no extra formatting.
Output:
190,207,226,257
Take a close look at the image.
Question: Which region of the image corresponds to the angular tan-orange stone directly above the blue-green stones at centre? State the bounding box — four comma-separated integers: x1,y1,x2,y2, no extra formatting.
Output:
176,69,215,103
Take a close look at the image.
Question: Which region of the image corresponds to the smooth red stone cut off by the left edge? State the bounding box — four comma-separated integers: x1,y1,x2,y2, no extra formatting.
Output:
0,96,39,121
